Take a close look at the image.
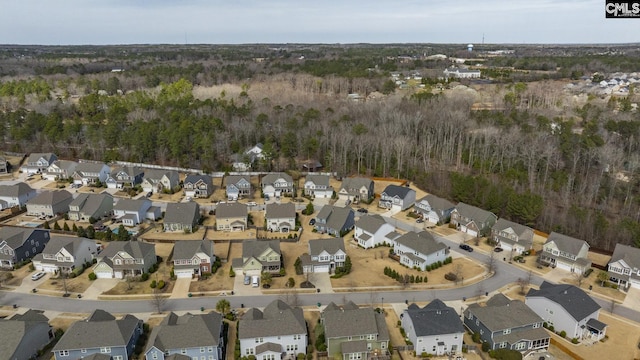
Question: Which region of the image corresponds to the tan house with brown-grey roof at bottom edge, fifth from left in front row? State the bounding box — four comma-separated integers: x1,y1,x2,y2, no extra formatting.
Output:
321,301,391,360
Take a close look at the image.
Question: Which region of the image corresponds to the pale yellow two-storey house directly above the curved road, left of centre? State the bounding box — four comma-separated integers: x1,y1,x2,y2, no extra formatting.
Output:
232,240,282,275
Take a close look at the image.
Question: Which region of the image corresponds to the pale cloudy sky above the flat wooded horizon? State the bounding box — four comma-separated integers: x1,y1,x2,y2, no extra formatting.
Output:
0,0,640,45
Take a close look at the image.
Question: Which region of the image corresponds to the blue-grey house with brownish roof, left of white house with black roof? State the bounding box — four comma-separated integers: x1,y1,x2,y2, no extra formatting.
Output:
463,294,550,353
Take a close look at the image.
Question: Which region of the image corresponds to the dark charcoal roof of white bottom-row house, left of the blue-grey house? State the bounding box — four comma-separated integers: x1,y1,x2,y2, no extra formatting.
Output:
404,299,464,337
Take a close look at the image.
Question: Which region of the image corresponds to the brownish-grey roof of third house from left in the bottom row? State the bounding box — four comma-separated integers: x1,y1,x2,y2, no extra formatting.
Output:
147,312,222,351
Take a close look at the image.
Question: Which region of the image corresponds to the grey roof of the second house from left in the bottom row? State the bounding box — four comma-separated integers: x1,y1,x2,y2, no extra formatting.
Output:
53,310,142,351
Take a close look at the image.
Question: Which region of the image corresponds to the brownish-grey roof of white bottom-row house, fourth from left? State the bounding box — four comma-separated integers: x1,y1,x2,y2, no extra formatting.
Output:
239,300,307,339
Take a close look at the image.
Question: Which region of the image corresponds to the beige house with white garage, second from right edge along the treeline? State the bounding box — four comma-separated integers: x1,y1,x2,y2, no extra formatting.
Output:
538,232,591,274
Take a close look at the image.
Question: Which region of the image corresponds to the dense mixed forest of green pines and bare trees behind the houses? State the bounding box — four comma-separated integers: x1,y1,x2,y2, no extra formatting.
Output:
0,44,640,250
